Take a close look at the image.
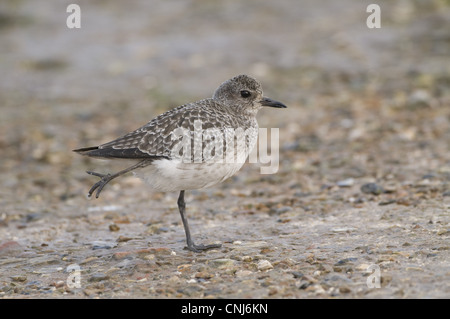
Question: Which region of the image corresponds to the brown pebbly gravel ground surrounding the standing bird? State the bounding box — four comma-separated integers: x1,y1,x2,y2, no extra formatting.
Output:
0,0,450,298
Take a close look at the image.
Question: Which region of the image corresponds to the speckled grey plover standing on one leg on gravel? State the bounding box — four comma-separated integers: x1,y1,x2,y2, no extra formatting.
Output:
74,75,286,252
